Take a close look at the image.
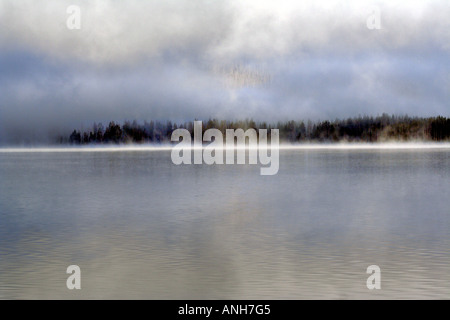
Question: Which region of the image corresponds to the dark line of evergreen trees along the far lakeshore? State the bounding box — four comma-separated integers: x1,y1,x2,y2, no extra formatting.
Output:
64,114,450,144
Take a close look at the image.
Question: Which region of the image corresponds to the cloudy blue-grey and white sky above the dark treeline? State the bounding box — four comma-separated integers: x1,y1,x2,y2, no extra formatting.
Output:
0,0,450,143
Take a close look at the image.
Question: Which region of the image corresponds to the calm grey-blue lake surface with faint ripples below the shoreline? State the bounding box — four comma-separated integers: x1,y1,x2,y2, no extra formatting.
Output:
0,149,450,299
